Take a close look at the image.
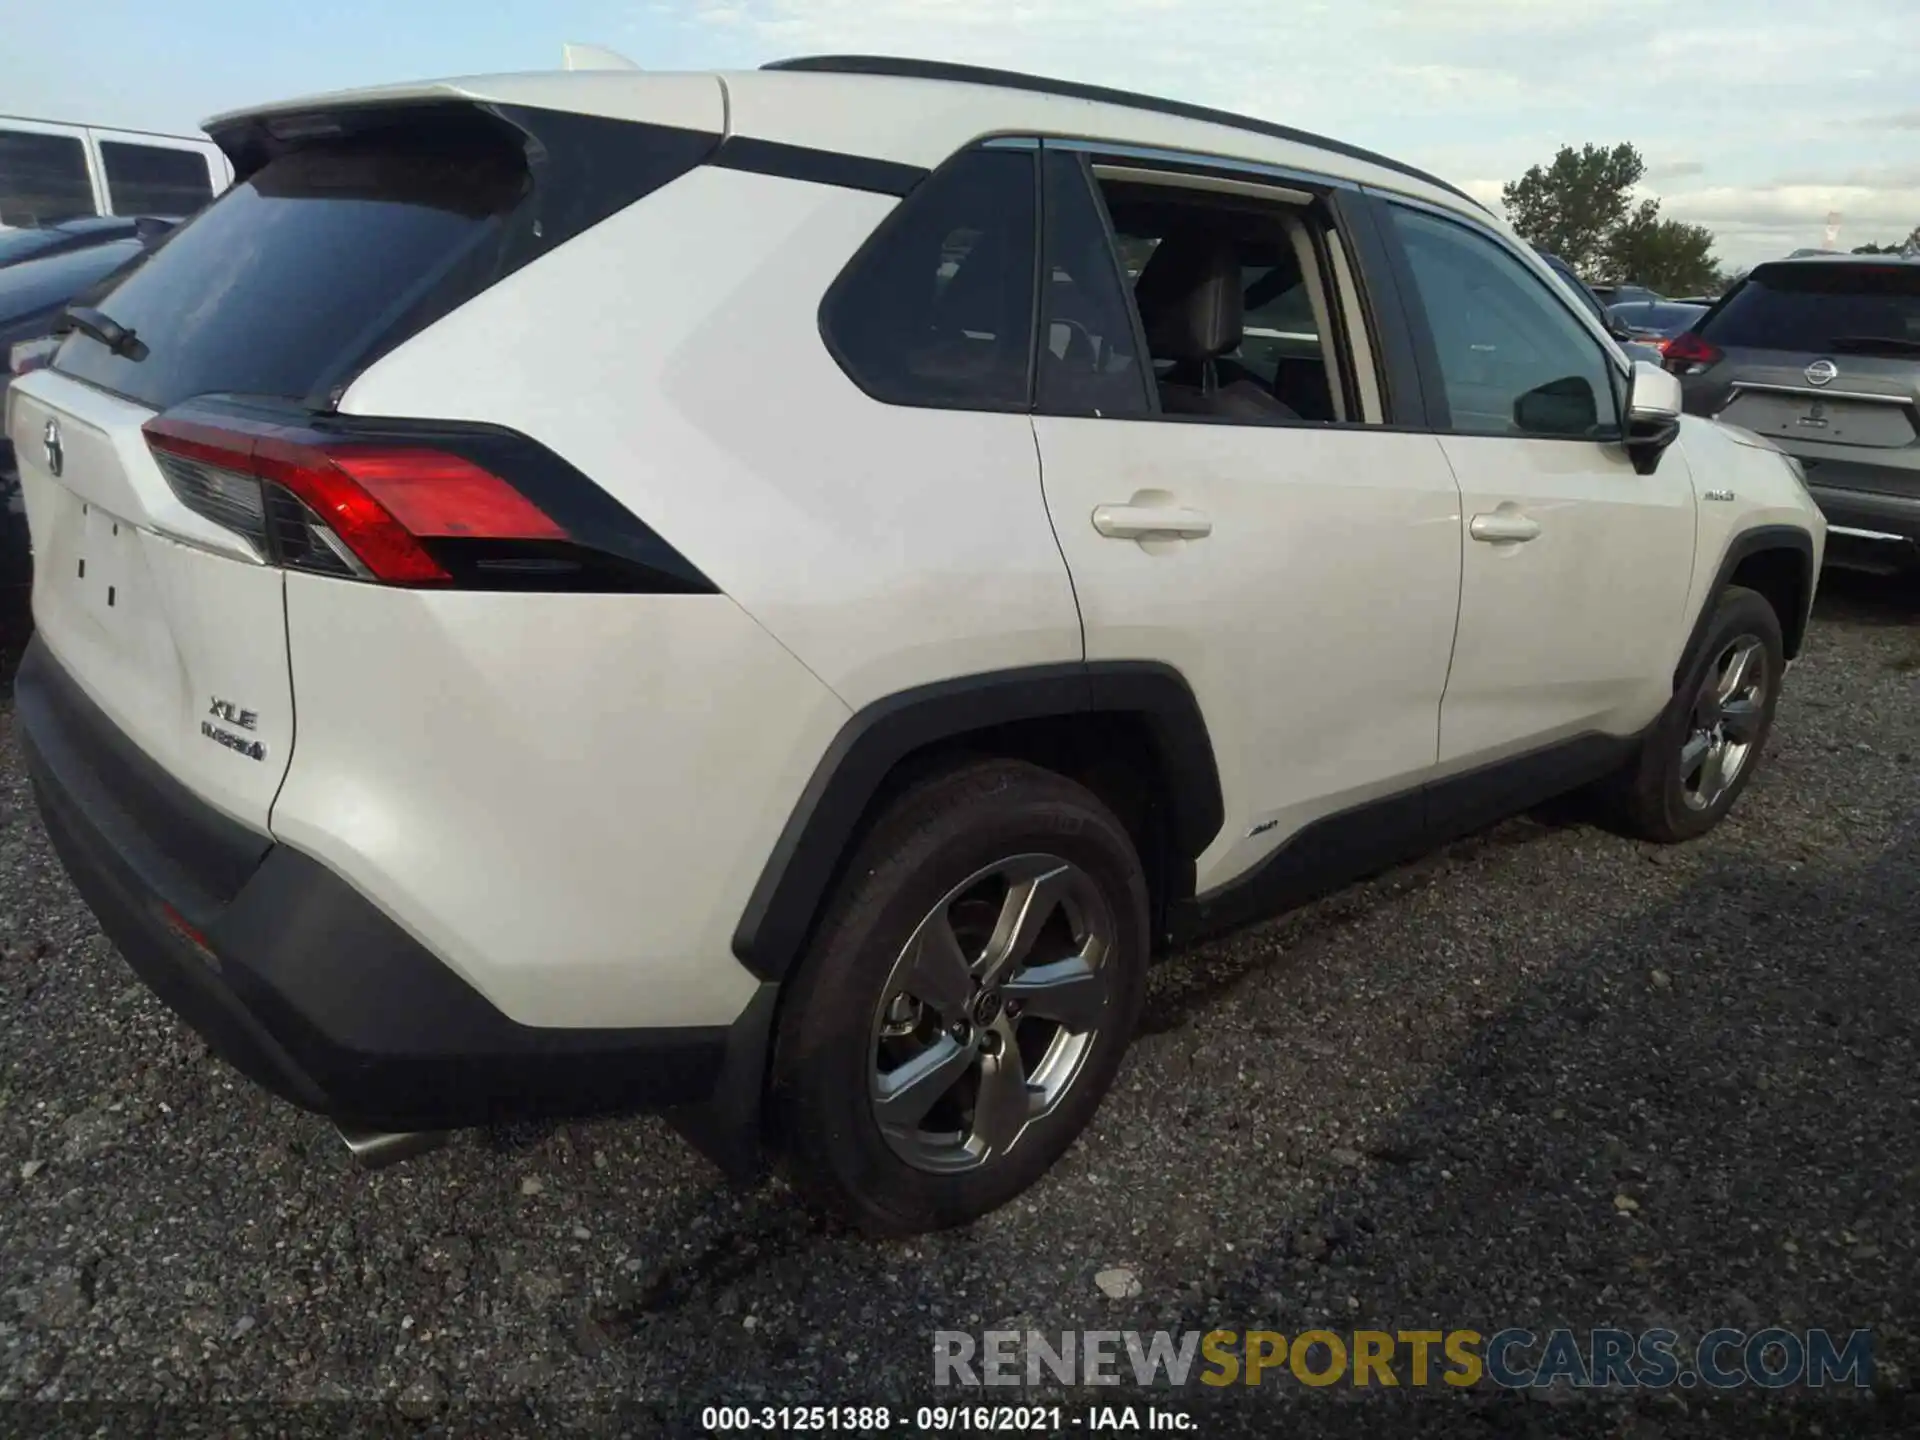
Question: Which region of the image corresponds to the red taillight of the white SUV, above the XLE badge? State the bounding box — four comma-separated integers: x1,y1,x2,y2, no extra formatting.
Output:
144,415,568,586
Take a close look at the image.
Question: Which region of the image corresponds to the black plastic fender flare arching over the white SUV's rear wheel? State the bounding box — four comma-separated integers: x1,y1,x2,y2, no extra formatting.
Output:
733,660,1225,979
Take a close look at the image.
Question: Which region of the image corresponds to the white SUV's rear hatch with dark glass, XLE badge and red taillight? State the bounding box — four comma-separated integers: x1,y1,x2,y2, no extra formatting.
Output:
6,87,722,831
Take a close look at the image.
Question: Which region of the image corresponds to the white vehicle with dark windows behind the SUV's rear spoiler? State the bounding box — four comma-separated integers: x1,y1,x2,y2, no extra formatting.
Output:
0,115,232,234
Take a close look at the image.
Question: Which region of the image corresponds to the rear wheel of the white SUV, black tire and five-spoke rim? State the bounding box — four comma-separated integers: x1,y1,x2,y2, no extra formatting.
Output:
768,760,1150,1235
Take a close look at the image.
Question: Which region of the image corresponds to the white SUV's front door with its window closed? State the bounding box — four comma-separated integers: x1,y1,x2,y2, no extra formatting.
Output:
1386,204,1695,770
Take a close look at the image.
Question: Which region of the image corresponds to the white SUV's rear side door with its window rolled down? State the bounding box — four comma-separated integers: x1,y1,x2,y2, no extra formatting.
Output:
1035,142,1461,891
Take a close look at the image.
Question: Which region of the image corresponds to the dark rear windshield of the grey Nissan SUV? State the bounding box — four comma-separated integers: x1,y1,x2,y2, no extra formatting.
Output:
1701,265,1920,351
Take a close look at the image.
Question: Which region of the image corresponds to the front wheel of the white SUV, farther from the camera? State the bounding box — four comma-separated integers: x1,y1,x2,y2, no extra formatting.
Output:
1609,586,1786,845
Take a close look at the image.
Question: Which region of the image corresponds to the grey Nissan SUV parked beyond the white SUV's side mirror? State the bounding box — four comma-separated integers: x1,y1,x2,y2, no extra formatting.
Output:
1667,255,1920,563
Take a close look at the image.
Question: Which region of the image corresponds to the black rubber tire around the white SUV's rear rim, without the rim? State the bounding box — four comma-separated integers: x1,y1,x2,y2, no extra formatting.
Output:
776,764,1150,1231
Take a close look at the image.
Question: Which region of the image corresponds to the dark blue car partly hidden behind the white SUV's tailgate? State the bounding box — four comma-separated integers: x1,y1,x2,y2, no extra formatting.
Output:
0,221,173,637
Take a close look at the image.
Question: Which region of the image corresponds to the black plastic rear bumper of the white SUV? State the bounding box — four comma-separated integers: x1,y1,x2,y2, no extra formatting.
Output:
15,639,772,1148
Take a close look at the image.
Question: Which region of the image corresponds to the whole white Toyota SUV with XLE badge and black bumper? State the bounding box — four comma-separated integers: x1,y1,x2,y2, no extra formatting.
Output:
8,58,1824,1233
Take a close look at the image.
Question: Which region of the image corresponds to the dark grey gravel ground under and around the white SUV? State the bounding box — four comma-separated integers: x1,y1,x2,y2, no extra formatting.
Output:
0,574,1920,1436
